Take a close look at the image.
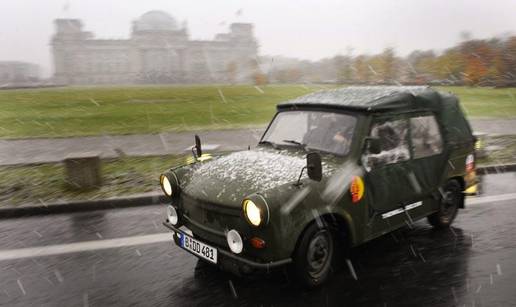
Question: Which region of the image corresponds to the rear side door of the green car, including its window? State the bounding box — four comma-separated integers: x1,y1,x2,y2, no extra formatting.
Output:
409,113,446,198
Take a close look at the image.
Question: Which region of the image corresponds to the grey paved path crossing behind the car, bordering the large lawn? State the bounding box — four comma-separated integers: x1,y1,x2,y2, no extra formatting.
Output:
0,119,516,165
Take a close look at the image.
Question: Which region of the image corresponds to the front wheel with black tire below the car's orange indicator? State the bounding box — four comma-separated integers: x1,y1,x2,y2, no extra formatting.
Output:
290,223,335,288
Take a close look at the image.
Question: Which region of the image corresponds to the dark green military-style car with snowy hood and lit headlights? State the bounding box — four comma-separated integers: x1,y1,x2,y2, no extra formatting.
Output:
160,86,475,287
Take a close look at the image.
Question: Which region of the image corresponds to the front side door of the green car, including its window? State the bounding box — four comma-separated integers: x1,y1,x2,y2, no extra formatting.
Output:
362,115,414,235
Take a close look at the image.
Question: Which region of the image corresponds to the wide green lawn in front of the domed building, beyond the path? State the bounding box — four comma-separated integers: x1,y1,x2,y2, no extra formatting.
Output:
0,85,516,138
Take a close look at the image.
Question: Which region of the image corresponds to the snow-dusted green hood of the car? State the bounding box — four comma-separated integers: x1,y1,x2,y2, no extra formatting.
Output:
180,148,318,207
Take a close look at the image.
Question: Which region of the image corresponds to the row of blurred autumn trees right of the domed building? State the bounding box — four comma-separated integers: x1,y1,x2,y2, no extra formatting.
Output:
268,36,516,86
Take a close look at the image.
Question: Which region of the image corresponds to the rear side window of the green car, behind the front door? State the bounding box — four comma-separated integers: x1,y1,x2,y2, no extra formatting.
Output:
410,115,443,159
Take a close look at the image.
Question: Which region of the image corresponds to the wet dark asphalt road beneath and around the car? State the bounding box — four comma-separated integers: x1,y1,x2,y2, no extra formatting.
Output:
0,173,516,306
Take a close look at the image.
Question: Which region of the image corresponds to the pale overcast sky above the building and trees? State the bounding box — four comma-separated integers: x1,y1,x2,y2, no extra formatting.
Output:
0,0,516,75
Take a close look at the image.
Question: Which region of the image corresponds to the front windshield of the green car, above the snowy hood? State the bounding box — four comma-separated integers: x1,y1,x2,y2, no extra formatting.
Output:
261,111,356,155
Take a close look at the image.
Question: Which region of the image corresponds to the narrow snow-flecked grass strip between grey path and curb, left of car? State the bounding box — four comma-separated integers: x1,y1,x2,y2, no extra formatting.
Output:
0,156,186,206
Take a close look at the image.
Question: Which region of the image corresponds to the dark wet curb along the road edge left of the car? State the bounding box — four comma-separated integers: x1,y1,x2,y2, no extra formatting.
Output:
0,193,167,219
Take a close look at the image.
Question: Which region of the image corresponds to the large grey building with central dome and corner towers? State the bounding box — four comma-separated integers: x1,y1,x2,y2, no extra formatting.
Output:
51,11,258,85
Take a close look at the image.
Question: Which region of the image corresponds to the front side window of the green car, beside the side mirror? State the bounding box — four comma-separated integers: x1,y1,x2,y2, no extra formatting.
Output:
364,119,410,169
